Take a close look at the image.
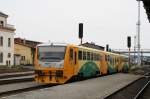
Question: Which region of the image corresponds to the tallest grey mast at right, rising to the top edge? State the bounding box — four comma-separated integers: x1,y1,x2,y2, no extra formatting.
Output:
137,0,141,66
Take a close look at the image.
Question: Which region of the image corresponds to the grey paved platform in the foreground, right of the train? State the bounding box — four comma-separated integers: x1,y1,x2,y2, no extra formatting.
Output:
1,73,141,99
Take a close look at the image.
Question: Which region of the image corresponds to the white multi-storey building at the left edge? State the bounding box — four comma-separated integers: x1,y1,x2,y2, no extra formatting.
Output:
0,12,15,66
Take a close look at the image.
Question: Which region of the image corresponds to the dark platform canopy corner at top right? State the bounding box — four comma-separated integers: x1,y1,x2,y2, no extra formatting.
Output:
141,0,150,22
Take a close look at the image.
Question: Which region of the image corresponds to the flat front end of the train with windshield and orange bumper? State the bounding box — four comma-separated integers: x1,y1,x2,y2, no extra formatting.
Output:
35,44,67,84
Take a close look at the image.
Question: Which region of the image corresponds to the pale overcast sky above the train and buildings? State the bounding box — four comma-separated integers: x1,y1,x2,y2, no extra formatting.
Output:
0,0,150,49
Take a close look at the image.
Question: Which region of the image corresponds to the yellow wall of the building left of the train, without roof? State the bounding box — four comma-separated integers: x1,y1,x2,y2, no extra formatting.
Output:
14,43,33,65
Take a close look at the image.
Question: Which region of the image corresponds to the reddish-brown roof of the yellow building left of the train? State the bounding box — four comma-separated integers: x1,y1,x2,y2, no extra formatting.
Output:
14,38,42,48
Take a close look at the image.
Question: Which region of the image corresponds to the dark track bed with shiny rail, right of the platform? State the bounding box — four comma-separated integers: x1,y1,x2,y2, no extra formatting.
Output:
105,73,150,99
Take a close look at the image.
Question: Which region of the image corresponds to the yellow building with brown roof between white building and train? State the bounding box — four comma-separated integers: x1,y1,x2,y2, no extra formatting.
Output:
14,38,40,65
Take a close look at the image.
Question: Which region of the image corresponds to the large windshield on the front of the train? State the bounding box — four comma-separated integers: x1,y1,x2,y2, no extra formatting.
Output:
38,46,66,62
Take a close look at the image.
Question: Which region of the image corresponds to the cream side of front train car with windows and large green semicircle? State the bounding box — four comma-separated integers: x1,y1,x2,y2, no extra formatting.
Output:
77,48,101,77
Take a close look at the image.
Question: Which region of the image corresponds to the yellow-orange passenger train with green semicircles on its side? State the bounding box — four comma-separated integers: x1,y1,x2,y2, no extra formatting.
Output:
35,43,129,84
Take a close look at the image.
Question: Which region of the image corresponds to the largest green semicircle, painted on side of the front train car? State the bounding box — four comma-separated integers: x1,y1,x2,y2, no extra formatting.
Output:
79,62,100,77
